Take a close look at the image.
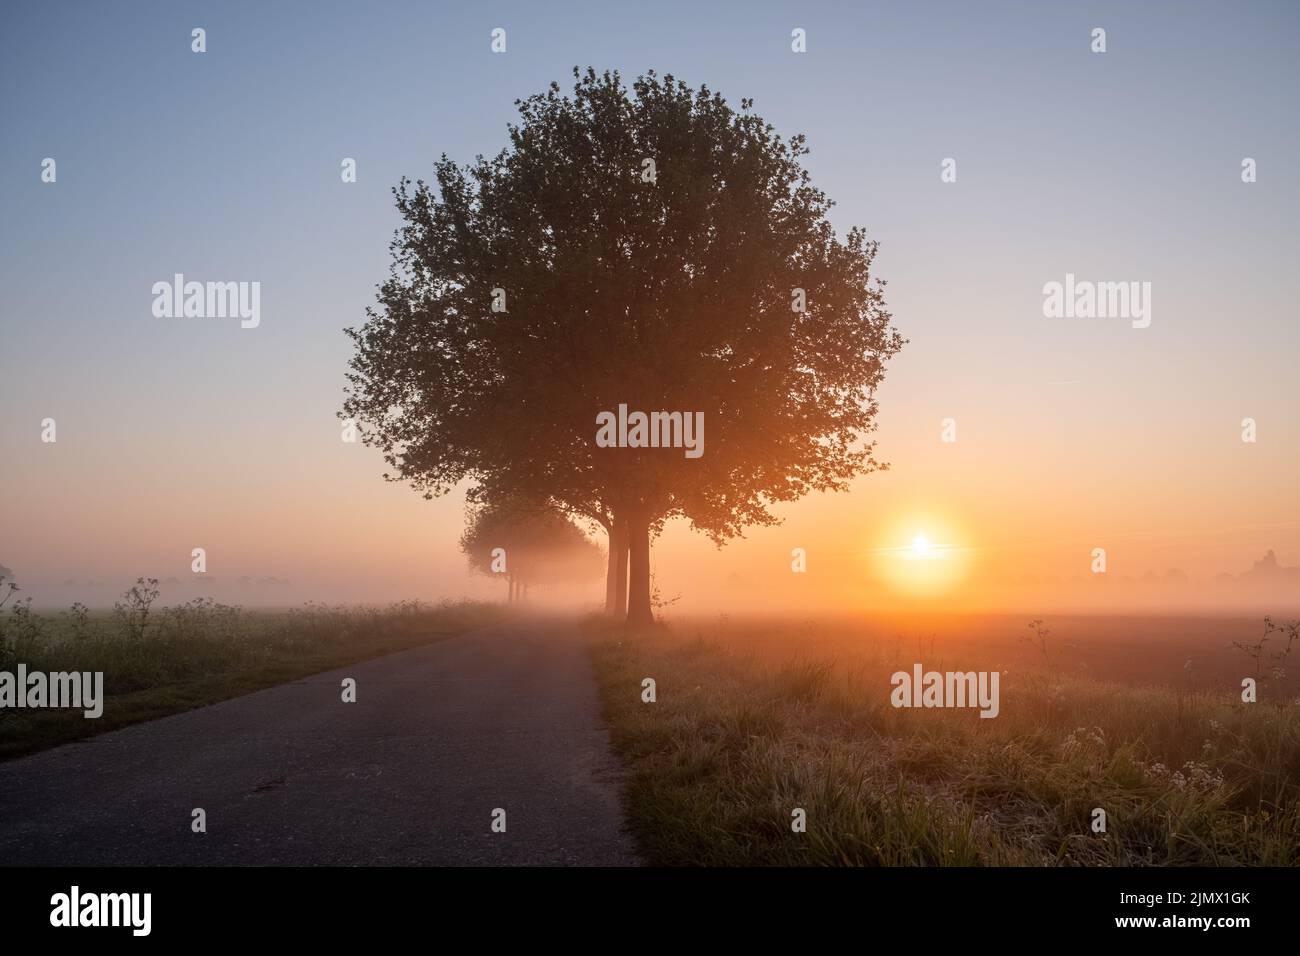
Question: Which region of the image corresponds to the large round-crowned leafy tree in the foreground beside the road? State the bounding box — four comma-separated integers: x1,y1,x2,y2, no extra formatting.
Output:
343,69,904,623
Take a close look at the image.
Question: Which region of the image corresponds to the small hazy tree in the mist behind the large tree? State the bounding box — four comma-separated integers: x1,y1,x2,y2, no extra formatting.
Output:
460,501,602,602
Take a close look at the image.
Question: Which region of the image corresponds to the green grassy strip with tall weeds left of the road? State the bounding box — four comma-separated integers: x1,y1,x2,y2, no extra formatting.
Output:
0,581,503,760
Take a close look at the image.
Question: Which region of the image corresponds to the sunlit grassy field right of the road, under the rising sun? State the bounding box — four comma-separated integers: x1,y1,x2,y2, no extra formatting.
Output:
589,620,1300,866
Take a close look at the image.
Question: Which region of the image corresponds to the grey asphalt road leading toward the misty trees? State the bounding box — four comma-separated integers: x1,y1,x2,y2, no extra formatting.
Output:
0,620,637,865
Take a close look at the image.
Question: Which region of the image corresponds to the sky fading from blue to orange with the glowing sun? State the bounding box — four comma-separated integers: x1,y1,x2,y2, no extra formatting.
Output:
0,3,1300,609
